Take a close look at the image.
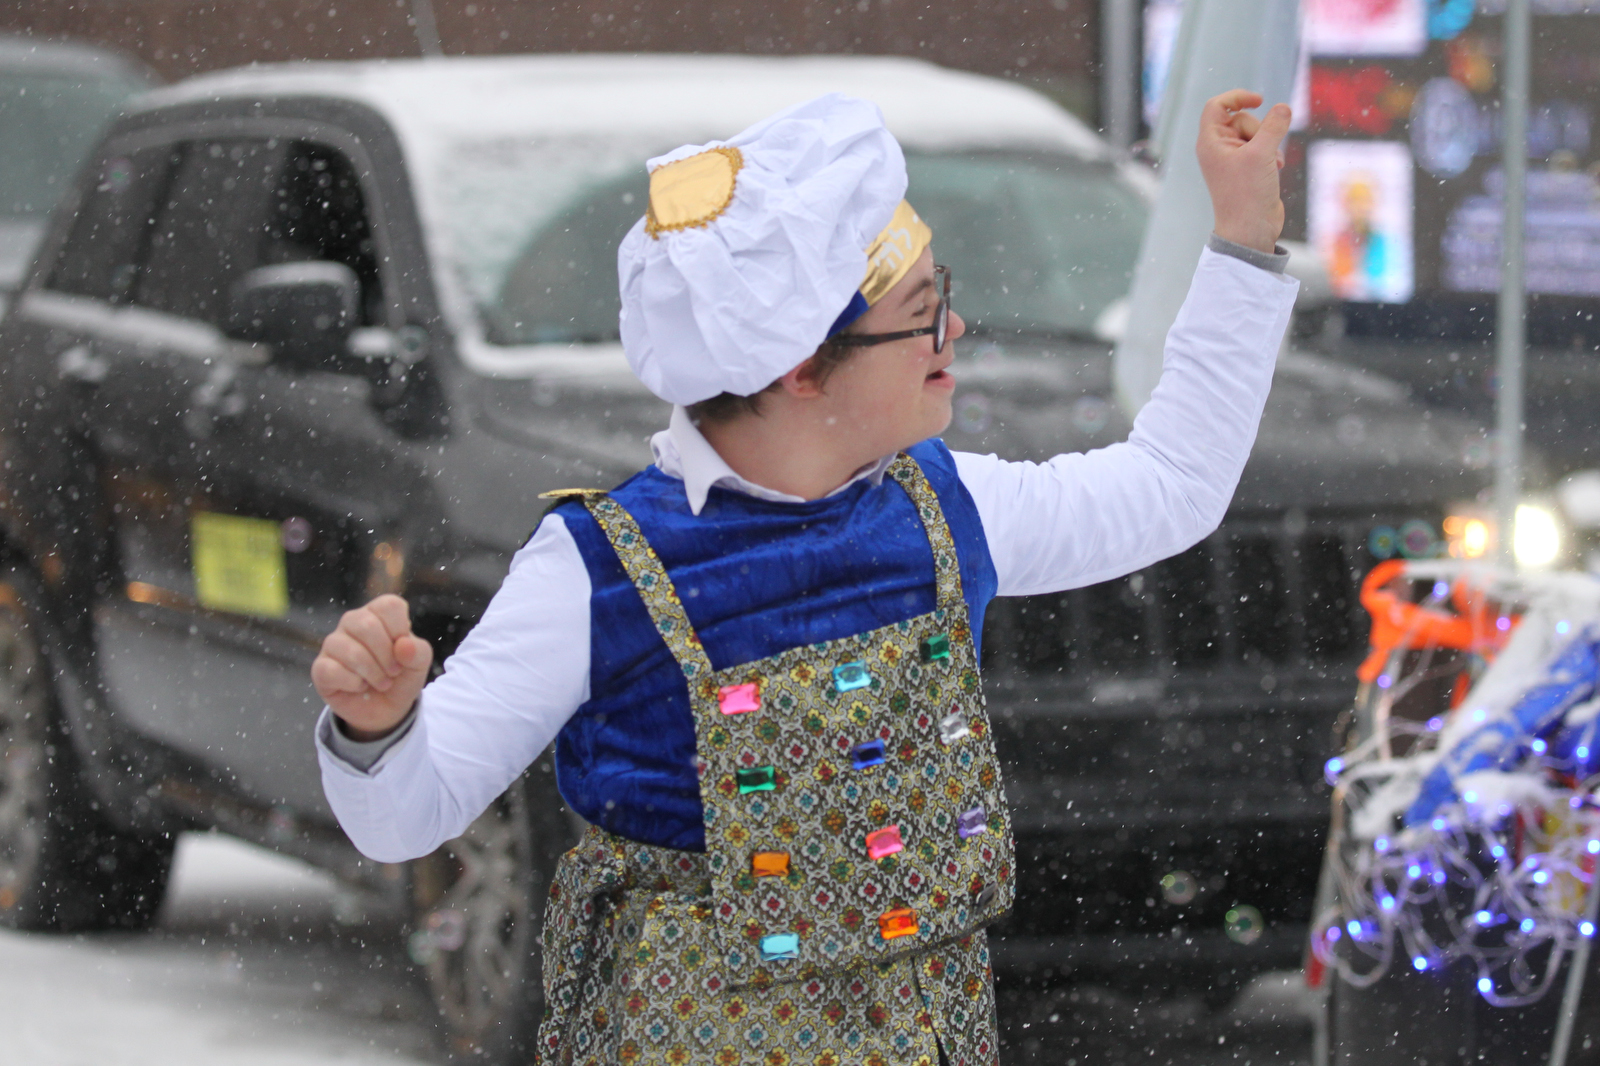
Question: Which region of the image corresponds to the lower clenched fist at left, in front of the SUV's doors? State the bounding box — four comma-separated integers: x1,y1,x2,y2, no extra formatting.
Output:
310,595,434,741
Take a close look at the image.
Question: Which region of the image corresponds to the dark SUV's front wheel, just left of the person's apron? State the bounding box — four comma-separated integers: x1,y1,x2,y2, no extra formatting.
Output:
406,754,578,1066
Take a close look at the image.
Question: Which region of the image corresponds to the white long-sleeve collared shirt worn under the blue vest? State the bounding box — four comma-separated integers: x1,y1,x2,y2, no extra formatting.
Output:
317,238,1299,863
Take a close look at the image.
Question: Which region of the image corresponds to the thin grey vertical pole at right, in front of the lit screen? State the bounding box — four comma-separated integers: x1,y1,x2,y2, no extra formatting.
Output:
1494,0,1531,567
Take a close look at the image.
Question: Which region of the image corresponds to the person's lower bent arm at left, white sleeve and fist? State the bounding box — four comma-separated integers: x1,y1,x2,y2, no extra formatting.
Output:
312,515,589,863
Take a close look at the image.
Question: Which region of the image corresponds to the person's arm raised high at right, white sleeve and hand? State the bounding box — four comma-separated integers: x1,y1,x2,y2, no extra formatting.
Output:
955,90,1298,595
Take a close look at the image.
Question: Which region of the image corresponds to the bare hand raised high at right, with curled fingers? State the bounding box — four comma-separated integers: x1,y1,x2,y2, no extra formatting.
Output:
1195,90,1291,253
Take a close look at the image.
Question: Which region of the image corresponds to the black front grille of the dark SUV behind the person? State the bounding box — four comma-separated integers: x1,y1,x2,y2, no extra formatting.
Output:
984,511,1438,681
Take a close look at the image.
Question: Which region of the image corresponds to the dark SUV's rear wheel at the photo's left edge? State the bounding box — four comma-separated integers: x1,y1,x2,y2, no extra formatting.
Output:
0,568,174,933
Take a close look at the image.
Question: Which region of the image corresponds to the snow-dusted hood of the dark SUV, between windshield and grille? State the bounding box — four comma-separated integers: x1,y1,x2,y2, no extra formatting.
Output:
467,338,1488,511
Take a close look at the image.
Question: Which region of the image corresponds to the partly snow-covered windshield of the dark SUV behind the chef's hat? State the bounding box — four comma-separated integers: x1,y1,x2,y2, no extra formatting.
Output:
437,144,1147,344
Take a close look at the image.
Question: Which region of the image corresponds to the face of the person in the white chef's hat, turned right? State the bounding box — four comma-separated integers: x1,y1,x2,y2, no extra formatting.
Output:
822,248,966,455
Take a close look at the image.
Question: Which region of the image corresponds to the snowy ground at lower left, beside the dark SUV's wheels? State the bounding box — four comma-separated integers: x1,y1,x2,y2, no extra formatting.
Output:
0,834,440,1066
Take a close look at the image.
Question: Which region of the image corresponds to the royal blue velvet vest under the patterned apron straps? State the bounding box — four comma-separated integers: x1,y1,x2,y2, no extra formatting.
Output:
555,440,997,852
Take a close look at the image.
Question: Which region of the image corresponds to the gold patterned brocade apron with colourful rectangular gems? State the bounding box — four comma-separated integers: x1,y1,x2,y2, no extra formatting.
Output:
539,455,1013,1066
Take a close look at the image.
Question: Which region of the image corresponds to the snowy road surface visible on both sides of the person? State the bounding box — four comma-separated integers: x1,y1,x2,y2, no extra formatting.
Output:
0,834,1310,1066
